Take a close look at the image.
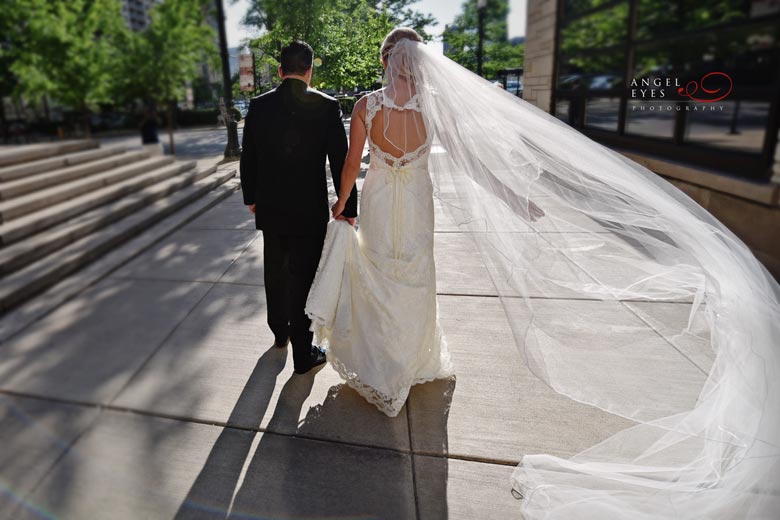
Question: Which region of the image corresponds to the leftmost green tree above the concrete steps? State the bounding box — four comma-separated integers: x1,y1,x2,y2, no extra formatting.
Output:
9,0,129,135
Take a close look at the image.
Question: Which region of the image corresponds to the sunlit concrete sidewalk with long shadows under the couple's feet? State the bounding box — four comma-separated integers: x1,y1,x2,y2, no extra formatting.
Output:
0,166,706,519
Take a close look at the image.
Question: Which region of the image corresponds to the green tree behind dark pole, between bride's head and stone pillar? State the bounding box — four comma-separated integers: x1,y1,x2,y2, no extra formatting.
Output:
444,0,525,78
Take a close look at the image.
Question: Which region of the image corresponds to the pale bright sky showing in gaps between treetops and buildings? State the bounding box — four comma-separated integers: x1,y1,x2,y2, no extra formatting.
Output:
225,0,526,48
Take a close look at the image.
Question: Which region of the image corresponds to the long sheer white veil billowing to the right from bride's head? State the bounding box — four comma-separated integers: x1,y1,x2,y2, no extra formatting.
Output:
385,40,780,519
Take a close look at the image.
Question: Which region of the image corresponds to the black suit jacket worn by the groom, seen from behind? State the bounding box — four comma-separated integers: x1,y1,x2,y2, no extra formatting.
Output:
240,78,357,235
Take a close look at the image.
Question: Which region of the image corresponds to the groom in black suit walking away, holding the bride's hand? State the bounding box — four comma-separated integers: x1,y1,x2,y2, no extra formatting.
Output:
240,41,357,374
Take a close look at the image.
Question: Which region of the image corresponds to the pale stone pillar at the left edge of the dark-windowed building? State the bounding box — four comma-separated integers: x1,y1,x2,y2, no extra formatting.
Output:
523,0,557,112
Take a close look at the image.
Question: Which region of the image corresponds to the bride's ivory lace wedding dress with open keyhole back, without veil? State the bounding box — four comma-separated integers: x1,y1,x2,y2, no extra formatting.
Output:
306,89,452,417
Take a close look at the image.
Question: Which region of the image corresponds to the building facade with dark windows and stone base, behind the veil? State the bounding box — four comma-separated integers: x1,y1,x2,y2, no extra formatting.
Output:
523,0,780,276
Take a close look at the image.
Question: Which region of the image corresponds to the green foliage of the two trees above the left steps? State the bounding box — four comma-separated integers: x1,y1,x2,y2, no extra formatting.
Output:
0,0,217,111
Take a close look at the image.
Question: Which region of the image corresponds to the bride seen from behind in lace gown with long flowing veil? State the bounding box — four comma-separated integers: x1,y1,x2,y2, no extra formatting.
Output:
307,29,780,519
